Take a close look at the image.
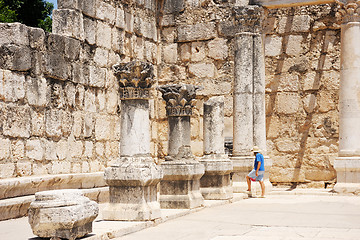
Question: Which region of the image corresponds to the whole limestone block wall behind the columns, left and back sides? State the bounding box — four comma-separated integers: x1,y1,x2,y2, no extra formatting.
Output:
0,0,340,187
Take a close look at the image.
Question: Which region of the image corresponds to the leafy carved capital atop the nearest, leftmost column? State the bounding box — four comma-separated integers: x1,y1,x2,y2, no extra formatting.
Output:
113,61,155,100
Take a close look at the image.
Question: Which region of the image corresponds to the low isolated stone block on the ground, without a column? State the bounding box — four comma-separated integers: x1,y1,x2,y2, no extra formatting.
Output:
28,189,99,240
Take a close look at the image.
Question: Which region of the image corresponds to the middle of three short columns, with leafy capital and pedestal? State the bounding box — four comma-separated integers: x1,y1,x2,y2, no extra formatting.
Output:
158,84,204,209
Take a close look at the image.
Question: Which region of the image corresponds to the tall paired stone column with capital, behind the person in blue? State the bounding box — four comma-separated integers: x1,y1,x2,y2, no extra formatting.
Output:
231,6,272,192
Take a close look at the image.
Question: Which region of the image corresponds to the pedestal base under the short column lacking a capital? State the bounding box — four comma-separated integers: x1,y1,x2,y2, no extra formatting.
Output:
200,155,233,200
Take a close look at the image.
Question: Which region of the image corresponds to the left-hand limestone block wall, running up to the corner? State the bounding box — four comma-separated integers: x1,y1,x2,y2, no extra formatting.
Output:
0,0,158,178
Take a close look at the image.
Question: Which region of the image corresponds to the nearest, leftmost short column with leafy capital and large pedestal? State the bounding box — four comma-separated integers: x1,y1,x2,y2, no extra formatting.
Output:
103,61,163,221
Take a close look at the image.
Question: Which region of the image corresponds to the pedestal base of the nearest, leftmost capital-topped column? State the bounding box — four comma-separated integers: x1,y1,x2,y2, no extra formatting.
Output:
103,157,163,221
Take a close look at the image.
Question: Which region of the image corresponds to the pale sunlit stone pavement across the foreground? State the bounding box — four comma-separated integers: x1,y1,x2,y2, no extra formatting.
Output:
0,189,360,240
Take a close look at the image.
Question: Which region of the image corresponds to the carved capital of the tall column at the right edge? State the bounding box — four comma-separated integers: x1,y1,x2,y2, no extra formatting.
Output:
336,0,360,23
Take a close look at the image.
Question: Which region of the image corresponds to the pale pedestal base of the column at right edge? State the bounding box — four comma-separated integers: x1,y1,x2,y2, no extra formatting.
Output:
334,157,360,195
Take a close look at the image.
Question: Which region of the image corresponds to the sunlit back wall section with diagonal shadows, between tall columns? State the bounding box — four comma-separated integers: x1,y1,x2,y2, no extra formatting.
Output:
265,5,340,187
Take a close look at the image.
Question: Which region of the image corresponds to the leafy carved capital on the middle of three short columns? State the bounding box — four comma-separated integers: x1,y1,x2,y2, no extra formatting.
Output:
158,84,203,117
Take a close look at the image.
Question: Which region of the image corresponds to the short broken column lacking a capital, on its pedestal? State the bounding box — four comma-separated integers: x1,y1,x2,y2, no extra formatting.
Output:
200,97,233,200
